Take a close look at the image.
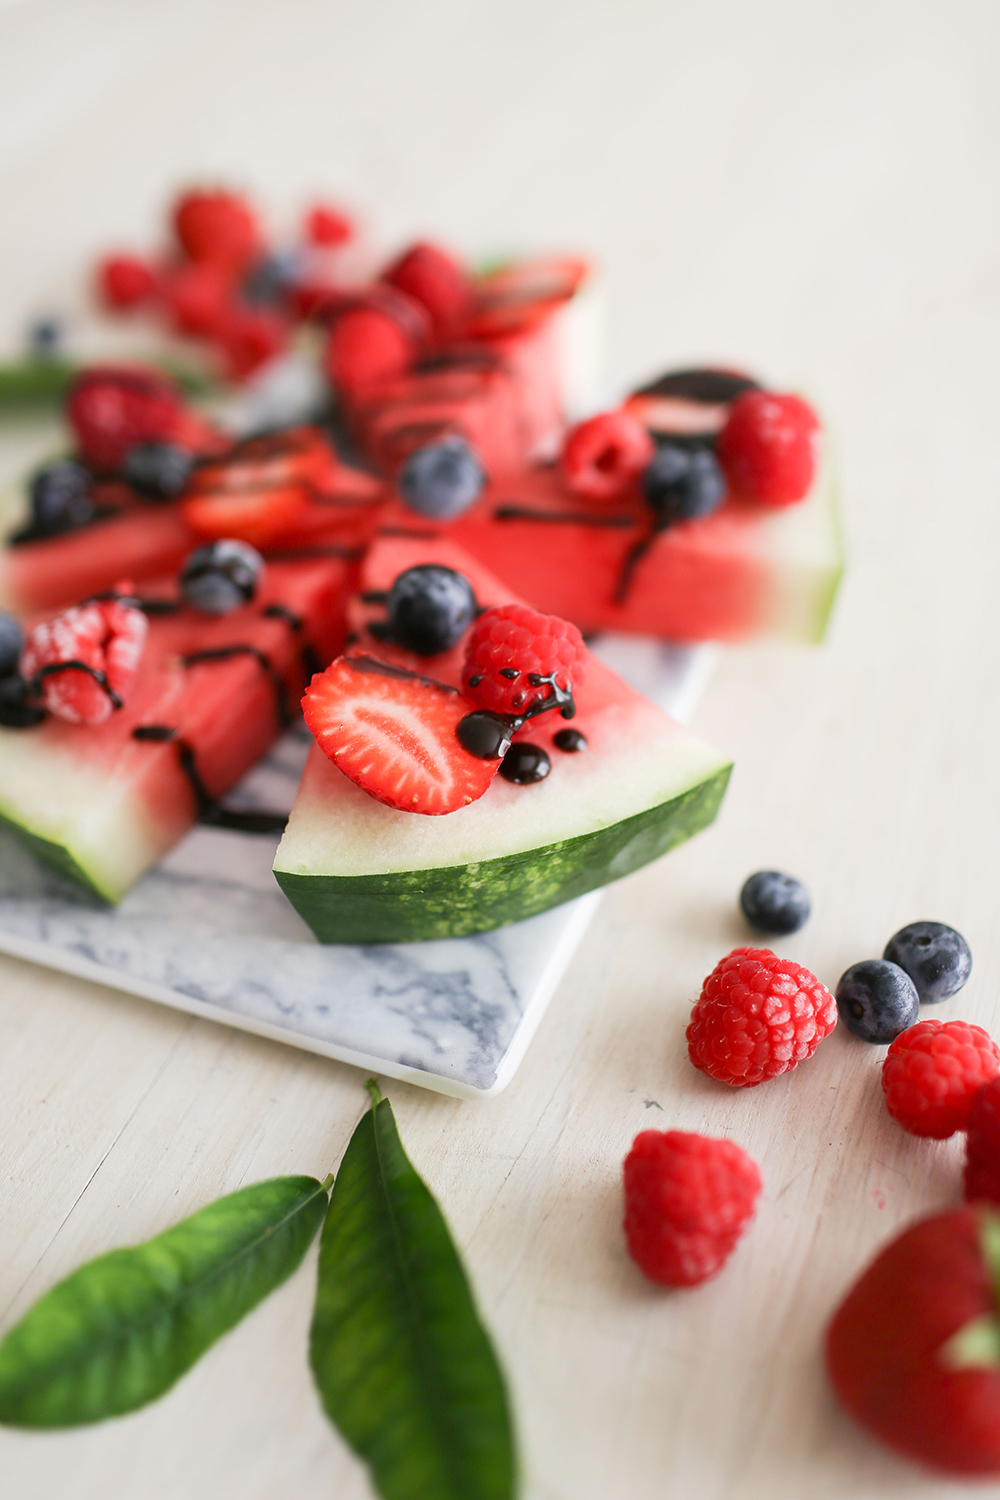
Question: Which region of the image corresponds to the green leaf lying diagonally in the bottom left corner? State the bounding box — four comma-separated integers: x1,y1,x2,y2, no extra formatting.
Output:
0,1178,331,1427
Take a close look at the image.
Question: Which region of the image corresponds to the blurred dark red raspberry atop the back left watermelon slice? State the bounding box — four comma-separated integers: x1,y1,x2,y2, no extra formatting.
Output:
66,366,186,470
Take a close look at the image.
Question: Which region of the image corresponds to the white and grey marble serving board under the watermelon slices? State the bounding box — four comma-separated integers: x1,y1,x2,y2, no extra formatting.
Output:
0,636,712,1098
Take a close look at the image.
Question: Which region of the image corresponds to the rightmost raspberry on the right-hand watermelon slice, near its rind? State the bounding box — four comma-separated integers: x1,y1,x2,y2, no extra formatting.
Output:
718,390,820,506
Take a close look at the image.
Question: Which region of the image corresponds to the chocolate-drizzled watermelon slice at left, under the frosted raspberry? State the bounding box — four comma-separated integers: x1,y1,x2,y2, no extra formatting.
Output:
0,560,354,902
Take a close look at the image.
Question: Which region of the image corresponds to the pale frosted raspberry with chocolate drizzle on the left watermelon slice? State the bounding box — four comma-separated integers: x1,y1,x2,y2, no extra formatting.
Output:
21,582,147,725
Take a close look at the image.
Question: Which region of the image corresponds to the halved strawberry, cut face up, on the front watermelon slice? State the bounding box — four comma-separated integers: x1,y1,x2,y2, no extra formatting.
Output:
303,657,499,815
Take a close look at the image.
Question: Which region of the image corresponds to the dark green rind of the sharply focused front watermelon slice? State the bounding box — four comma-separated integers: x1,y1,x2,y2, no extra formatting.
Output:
274,764,732,944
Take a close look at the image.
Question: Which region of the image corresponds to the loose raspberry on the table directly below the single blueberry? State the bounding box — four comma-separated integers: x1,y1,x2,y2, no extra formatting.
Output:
687,948,837,1089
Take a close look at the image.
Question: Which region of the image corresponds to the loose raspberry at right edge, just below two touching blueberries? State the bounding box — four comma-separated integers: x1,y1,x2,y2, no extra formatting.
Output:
882,1022,1000,1140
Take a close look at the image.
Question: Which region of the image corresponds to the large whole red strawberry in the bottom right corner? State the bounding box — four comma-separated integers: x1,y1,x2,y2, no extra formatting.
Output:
826,1208,1000,1476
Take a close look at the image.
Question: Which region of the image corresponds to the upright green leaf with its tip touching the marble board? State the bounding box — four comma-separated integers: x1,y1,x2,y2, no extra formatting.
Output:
310,1086,516,1500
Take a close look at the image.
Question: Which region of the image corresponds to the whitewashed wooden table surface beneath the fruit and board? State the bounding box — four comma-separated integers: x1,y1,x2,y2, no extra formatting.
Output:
0,0,1000,1500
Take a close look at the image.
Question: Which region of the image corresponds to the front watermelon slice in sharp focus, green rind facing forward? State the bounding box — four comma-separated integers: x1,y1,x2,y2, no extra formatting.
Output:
274,539,730,942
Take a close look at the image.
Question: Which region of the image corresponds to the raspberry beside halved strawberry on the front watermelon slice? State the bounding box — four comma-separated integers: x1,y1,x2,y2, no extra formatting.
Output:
462,605,586,717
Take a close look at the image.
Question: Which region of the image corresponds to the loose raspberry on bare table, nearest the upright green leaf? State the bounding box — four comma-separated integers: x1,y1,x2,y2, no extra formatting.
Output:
625,1130,760,1287
